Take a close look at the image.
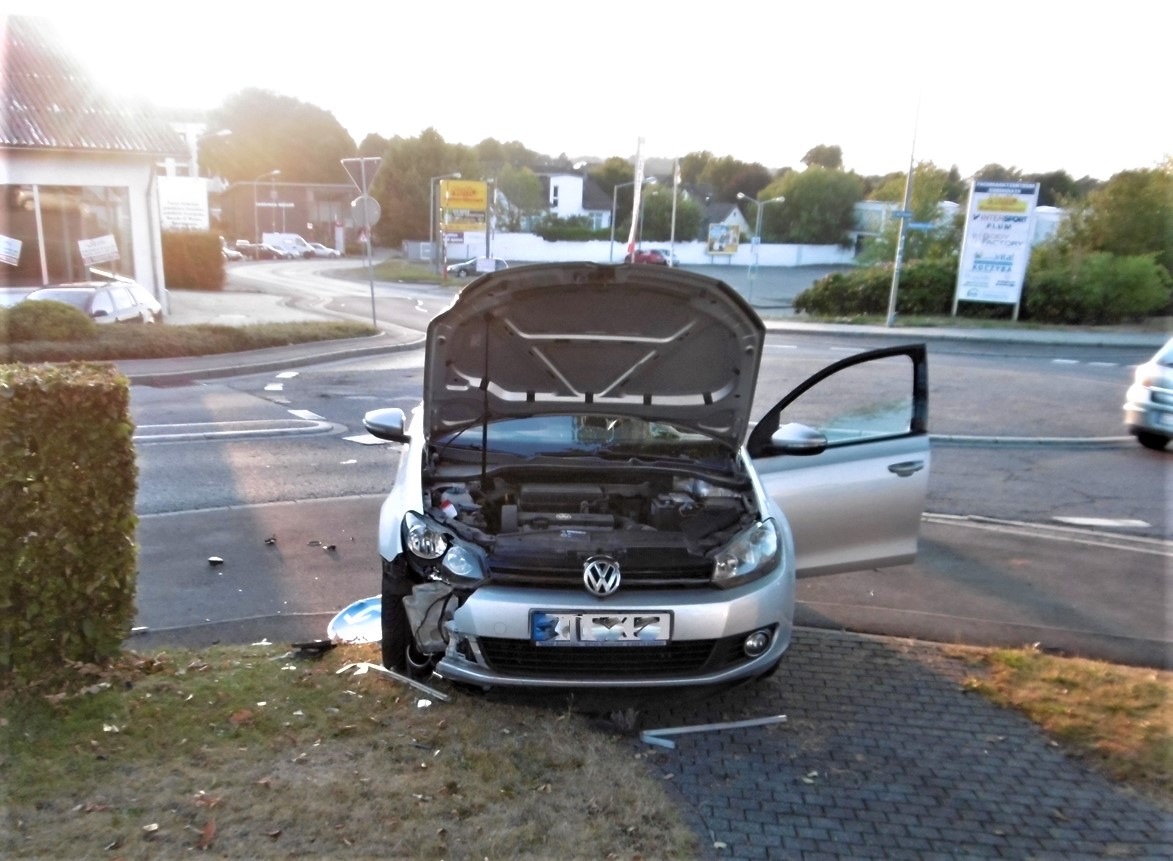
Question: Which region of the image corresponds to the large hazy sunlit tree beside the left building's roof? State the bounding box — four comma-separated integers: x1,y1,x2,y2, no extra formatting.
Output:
201,89,357,183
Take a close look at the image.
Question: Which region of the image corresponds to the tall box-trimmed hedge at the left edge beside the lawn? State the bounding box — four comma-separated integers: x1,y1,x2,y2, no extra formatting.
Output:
0,365,137,680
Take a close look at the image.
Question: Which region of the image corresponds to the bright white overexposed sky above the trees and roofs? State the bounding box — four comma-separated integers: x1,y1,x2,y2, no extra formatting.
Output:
6,0,1173,179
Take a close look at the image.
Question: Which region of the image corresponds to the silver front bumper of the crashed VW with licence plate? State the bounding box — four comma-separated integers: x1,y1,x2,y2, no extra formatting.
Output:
426,576,794,689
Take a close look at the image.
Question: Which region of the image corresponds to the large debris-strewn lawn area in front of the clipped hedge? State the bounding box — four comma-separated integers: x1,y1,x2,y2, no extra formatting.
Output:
0,645,697,859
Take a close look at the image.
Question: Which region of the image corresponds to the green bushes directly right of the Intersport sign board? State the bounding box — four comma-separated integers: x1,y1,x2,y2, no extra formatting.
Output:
1023,249,1173,325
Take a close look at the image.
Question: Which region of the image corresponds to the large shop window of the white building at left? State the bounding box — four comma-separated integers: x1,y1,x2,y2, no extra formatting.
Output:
0,185,135,286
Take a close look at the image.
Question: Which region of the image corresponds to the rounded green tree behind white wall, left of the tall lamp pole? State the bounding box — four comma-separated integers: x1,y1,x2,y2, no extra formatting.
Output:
751,164,863,245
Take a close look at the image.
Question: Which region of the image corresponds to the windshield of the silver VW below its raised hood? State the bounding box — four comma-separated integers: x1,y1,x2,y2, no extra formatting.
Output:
435,415,728,459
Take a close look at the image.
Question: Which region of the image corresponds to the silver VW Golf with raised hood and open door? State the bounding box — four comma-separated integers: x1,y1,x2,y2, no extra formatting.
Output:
364,263,929,687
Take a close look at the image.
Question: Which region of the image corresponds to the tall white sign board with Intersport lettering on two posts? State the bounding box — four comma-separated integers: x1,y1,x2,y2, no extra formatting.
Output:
952,179,1038,319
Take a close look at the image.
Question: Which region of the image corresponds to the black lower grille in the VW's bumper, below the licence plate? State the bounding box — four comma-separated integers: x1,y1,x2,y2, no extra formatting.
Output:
477,635,747,679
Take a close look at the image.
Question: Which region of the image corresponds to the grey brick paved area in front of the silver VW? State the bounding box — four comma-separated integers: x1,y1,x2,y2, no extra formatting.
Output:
639,629,1173,861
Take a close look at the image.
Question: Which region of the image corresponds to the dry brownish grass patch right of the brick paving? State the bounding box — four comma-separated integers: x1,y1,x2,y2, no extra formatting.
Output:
963,649,1173,808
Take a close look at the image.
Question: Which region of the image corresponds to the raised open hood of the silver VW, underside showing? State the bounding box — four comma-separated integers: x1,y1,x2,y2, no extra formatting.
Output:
423,263,765,447
